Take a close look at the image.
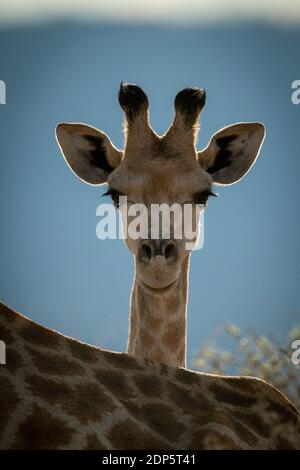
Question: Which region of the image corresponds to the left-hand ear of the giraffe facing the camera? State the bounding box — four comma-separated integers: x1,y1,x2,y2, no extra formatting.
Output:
56,123,123,185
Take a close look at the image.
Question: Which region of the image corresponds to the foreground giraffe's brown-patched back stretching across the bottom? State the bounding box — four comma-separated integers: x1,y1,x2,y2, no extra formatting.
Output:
0,304,300,450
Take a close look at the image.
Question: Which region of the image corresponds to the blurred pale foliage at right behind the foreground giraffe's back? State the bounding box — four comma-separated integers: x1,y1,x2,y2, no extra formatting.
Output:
192,324,300,408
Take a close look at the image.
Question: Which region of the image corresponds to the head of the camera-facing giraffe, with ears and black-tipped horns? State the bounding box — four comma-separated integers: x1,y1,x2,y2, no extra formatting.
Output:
56,83,265,295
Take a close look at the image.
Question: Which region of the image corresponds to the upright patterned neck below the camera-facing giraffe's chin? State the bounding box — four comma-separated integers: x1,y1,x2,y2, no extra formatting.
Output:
127,255,189,367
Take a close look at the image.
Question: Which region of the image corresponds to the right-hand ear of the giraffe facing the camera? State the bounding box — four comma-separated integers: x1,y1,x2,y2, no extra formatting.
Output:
198,122,265,185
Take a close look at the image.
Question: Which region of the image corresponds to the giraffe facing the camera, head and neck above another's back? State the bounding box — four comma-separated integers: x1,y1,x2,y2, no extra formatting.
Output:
56,83,265,367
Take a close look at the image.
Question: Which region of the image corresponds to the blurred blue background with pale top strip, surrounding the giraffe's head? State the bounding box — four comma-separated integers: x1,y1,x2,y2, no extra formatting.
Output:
0,0,300,376
